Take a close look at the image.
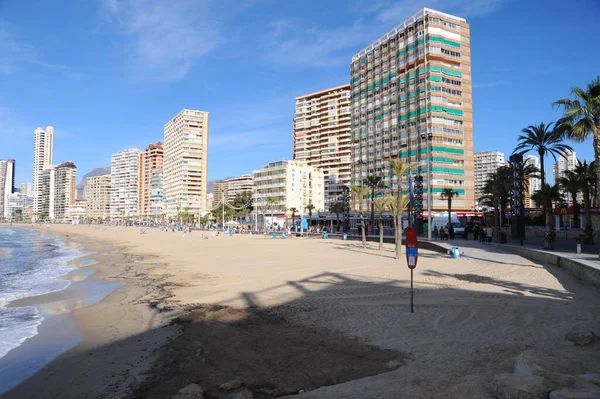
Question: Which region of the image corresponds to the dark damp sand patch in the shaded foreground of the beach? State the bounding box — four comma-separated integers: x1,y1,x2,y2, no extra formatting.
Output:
131,306,407,398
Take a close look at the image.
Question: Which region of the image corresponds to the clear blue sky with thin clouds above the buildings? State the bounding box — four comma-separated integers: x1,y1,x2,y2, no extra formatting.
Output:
0,0,600,183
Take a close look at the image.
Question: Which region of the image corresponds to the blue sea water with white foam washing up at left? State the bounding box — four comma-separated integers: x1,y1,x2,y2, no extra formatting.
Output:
0,225,81,358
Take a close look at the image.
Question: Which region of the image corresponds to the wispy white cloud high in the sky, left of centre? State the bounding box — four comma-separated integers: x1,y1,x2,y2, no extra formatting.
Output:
101,0,222,81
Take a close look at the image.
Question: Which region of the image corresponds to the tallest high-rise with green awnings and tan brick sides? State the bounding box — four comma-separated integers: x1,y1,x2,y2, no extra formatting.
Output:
350,8,474,211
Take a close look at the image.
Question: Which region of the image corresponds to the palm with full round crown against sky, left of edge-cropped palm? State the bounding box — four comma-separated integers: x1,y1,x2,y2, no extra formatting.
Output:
515,122,572,187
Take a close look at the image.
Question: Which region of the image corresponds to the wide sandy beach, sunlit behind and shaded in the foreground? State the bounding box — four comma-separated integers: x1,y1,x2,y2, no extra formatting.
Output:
3,225,600,398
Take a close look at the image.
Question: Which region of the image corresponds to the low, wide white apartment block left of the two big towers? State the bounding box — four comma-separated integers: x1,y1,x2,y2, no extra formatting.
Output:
254,161,325,219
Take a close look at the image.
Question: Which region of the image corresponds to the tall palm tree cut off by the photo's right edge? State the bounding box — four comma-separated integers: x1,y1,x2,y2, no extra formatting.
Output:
553,76,600,201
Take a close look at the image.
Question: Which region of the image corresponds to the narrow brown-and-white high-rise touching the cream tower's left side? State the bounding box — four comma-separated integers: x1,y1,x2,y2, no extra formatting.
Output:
139,142,164,216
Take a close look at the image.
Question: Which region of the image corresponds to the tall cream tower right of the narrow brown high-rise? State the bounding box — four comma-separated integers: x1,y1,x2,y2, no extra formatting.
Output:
163,109,209,216
